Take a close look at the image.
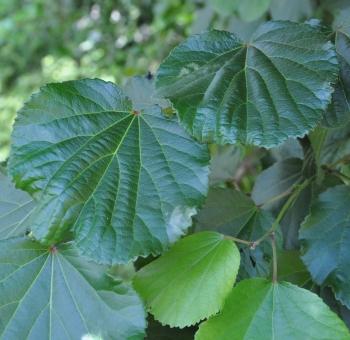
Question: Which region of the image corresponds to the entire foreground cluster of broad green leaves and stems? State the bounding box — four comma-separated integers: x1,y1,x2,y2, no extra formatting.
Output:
0,1,350,340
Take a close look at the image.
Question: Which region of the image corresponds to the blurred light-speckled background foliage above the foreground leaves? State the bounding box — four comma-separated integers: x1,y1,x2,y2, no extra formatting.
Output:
0,0,350,163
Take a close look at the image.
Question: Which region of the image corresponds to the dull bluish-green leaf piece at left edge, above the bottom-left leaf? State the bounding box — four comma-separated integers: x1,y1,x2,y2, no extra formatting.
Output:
0,173,35,240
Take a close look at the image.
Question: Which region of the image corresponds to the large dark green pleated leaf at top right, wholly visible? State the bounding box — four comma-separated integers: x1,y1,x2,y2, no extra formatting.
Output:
156,21,338,147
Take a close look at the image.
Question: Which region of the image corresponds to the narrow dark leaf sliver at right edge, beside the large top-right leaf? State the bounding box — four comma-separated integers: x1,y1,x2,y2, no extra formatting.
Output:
322,27,350,127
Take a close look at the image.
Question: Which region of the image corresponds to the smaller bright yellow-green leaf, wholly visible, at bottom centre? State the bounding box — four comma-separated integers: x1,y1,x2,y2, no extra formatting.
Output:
134,232,240,328
